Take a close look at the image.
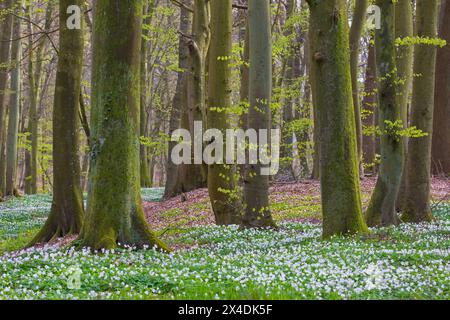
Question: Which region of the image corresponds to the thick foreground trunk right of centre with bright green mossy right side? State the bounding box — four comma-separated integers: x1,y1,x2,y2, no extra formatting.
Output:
307,0,367,238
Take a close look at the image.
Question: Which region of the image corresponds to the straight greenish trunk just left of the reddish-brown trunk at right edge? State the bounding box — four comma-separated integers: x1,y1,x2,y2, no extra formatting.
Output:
402,0,438,222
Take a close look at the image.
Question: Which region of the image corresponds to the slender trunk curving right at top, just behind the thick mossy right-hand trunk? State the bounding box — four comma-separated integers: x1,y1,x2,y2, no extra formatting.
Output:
350,0,369,176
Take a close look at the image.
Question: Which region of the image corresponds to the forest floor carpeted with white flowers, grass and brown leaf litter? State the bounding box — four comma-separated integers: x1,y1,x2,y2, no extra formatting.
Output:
0,179,450,299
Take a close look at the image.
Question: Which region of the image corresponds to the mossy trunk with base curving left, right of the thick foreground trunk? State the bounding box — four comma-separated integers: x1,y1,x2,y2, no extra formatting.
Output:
366,0,404,227
